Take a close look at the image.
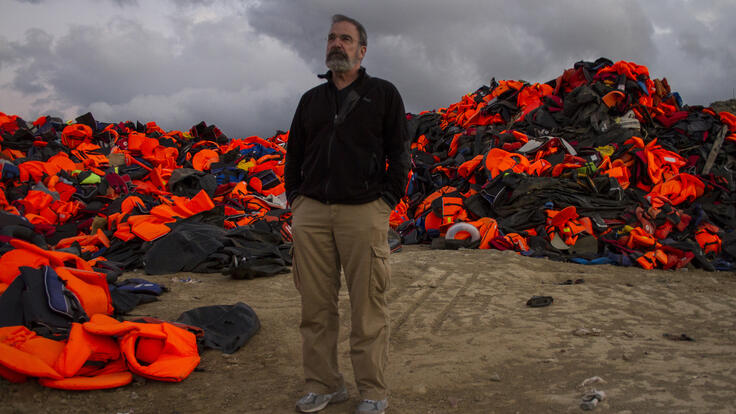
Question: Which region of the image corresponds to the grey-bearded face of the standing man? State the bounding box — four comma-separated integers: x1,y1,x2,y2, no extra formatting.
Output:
325,22,366,72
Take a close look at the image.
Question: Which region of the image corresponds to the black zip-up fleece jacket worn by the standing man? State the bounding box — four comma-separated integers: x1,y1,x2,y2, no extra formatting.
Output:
284,68,409,207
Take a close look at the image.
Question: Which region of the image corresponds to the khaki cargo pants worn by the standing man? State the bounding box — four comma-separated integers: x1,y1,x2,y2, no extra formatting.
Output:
292,196,391,400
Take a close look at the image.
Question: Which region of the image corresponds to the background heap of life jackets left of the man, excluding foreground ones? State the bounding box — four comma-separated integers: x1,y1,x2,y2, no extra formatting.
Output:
0,113,290,293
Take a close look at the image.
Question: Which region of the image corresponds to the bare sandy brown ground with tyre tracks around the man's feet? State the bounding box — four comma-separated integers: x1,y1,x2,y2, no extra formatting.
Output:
0,246,736,414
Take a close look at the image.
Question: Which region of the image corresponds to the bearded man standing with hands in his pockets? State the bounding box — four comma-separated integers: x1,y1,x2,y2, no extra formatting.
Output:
284,15,409,414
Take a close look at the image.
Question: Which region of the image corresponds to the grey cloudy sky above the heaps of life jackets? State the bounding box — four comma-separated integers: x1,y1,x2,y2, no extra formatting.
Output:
0,0,736,137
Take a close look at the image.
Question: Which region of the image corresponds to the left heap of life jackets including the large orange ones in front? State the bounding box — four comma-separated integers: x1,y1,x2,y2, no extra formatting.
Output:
0,113,291,389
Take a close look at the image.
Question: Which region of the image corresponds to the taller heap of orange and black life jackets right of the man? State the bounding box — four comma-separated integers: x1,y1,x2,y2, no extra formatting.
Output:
391,58,736,270
